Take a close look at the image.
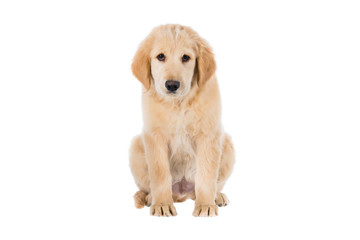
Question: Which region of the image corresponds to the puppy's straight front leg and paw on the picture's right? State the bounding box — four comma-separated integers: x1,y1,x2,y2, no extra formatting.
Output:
193,137,221,217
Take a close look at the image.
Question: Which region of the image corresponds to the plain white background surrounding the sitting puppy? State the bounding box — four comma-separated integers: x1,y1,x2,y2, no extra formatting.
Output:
0,0,360,240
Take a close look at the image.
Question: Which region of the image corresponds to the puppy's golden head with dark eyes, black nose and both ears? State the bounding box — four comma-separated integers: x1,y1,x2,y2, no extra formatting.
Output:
132,25,216,99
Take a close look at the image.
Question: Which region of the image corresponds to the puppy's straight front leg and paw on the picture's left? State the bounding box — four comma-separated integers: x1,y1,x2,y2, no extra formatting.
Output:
144,133,176,216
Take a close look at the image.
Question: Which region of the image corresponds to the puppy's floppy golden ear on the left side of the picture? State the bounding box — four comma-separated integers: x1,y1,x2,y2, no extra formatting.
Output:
131,38,151,89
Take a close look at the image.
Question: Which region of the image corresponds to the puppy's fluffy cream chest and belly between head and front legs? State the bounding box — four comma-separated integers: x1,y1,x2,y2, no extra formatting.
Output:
143,79,221,193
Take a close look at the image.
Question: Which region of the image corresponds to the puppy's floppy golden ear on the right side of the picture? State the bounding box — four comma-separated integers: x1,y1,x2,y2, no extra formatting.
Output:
196,39,216,87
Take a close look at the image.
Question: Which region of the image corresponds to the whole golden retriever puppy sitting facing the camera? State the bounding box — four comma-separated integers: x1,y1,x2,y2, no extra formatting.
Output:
130,25,234,217
